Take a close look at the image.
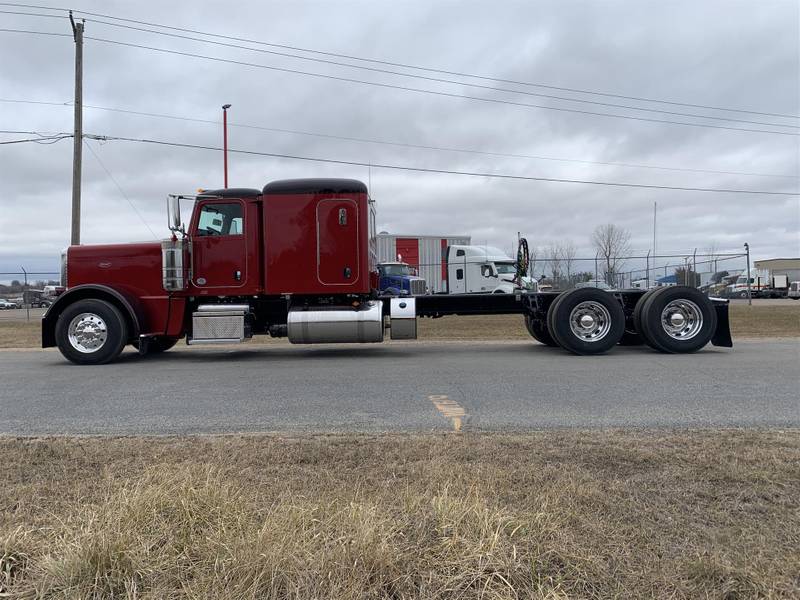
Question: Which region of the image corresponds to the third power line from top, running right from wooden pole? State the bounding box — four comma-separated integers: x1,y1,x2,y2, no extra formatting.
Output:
84,36,800,136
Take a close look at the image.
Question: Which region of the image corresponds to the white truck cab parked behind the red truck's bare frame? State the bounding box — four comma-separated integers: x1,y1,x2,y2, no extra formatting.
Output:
447,246,536,294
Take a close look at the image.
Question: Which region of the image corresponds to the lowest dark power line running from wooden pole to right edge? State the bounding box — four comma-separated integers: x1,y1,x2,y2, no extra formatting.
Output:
85,134,799,196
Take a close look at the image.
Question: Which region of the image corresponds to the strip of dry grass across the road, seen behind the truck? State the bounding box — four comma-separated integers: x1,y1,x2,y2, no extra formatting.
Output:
0,303,800,348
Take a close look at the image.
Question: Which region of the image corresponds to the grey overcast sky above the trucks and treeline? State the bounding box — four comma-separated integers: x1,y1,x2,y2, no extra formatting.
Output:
0,0,800,278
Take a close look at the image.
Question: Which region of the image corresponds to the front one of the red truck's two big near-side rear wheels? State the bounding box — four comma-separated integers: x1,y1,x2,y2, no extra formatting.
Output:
547,288,625,354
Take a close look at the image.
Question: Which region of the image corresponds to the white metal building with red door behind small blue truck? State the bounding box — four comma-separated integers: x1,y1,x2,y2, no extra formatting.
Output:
378,231,472,292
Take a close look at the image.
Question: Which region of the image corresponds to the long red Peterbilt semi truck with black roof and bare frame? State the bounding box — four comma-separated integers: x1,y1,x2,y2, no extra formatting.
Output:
42,179,732,364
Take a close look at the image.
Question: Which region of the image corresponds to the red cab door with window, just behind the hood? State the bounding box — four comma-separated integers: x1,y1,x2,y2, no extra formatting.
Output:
191,199,248,296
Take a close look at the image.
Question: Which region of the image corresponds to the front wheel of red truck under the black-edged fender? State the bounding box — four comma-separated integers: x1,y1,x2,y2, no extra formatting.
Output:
56,300,128,365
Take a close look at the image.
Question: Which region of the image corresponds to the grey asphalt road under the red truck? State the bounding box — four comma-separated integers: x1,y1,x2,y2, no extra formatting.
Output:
0,340,800,435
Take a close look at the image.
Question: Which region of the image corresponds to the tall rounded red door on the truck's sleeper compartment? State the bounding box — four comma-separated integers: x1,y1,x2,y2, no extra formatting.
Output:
317,198,360,286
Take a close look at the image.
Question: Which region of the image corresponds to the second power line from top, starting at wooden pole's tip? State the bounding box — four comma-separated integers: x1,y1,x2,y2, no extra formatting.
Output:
53,14,798,129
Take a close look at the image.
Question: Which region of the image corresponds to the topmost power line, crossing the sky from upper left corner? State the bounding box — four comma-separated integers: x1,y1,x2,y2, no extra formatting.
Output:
0,2,800,119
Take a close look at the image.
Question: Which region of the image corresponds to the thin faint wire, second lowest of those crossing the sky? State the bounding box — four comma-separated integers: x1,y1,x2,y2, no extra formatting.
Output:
0,98,798,179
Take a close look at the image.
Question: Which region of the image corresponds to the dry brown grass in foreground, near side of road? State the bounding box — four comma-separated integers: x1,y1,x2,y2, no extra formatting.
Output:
0,430,800,599
